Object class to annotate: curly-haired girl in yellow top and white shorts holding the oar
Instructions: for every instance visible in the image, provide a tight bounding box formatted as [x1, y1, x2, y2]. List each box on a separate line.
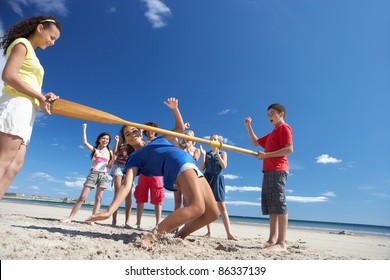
[0, 16, 61, 199]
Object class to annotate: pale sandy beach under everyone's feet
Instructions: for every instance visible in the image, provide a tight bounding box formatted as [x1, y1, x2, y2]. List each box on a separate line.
[0, 201, 390, 260]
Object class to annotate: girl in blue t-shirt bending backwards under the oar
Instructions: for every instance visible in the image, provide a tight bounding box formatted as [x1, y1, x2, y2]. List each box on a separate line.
[87, 98, 219, 249]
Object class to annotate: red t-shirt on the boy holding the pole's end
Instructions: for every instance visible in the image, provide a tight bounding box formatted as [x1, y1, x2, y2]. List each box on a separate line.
[257, 123, 292, 171]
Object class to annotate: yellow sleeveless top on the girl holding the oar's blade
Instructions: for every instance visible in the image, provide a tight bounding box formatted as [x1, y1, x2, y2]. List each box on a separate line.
[3, 38, 44, 111]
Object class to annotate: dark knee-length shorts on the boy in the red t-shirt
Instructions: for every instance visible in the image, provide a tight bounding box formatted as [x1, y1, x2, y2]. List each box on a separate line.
[261, 171, 288, 215]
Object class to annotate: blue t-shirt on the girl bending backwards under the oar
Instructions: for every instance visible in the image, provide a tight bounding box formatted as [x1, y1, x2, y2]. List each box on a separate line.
[126, 137, 195, 191]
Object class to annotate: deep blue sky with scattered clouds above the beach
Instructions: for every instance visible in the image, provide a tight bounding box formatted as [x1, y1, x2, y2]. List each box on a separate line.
[0, 0, 390, 226]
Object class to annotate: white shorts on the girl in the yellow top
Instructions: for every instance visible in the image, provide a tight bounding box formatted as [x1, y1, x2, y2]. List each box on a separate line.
[0, 94, 38, 145]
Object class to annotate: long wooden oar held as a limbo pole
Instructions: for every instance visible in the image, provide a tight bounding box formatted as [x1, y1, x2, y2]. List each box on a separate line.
[51, 98, 257, 156]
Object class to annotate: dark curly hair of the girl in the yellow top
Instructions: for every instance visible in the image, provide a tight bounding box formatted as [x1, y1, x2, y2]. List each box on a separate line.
[0, 16, 62, 55]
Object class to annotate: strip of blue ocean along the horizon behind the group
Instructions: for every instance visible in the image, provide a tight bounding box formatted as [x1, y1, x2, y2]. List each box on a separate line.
[2, 197, 390, 236]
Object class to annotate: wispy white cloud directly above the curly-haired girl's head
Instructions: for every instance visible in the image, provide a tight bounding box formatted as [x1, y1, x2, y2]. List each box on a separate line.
[7, 0, 69, 17]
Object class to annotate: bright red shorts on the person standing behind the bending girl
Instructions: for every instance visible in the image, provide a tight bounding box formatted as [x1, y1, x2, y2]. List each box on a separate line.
[134, 174, 165, 205]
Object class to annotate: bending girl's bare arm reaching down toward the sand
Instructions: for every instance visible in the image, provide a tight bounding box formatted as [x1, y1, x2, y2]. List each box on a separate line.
[85, 167, 138, 222]
